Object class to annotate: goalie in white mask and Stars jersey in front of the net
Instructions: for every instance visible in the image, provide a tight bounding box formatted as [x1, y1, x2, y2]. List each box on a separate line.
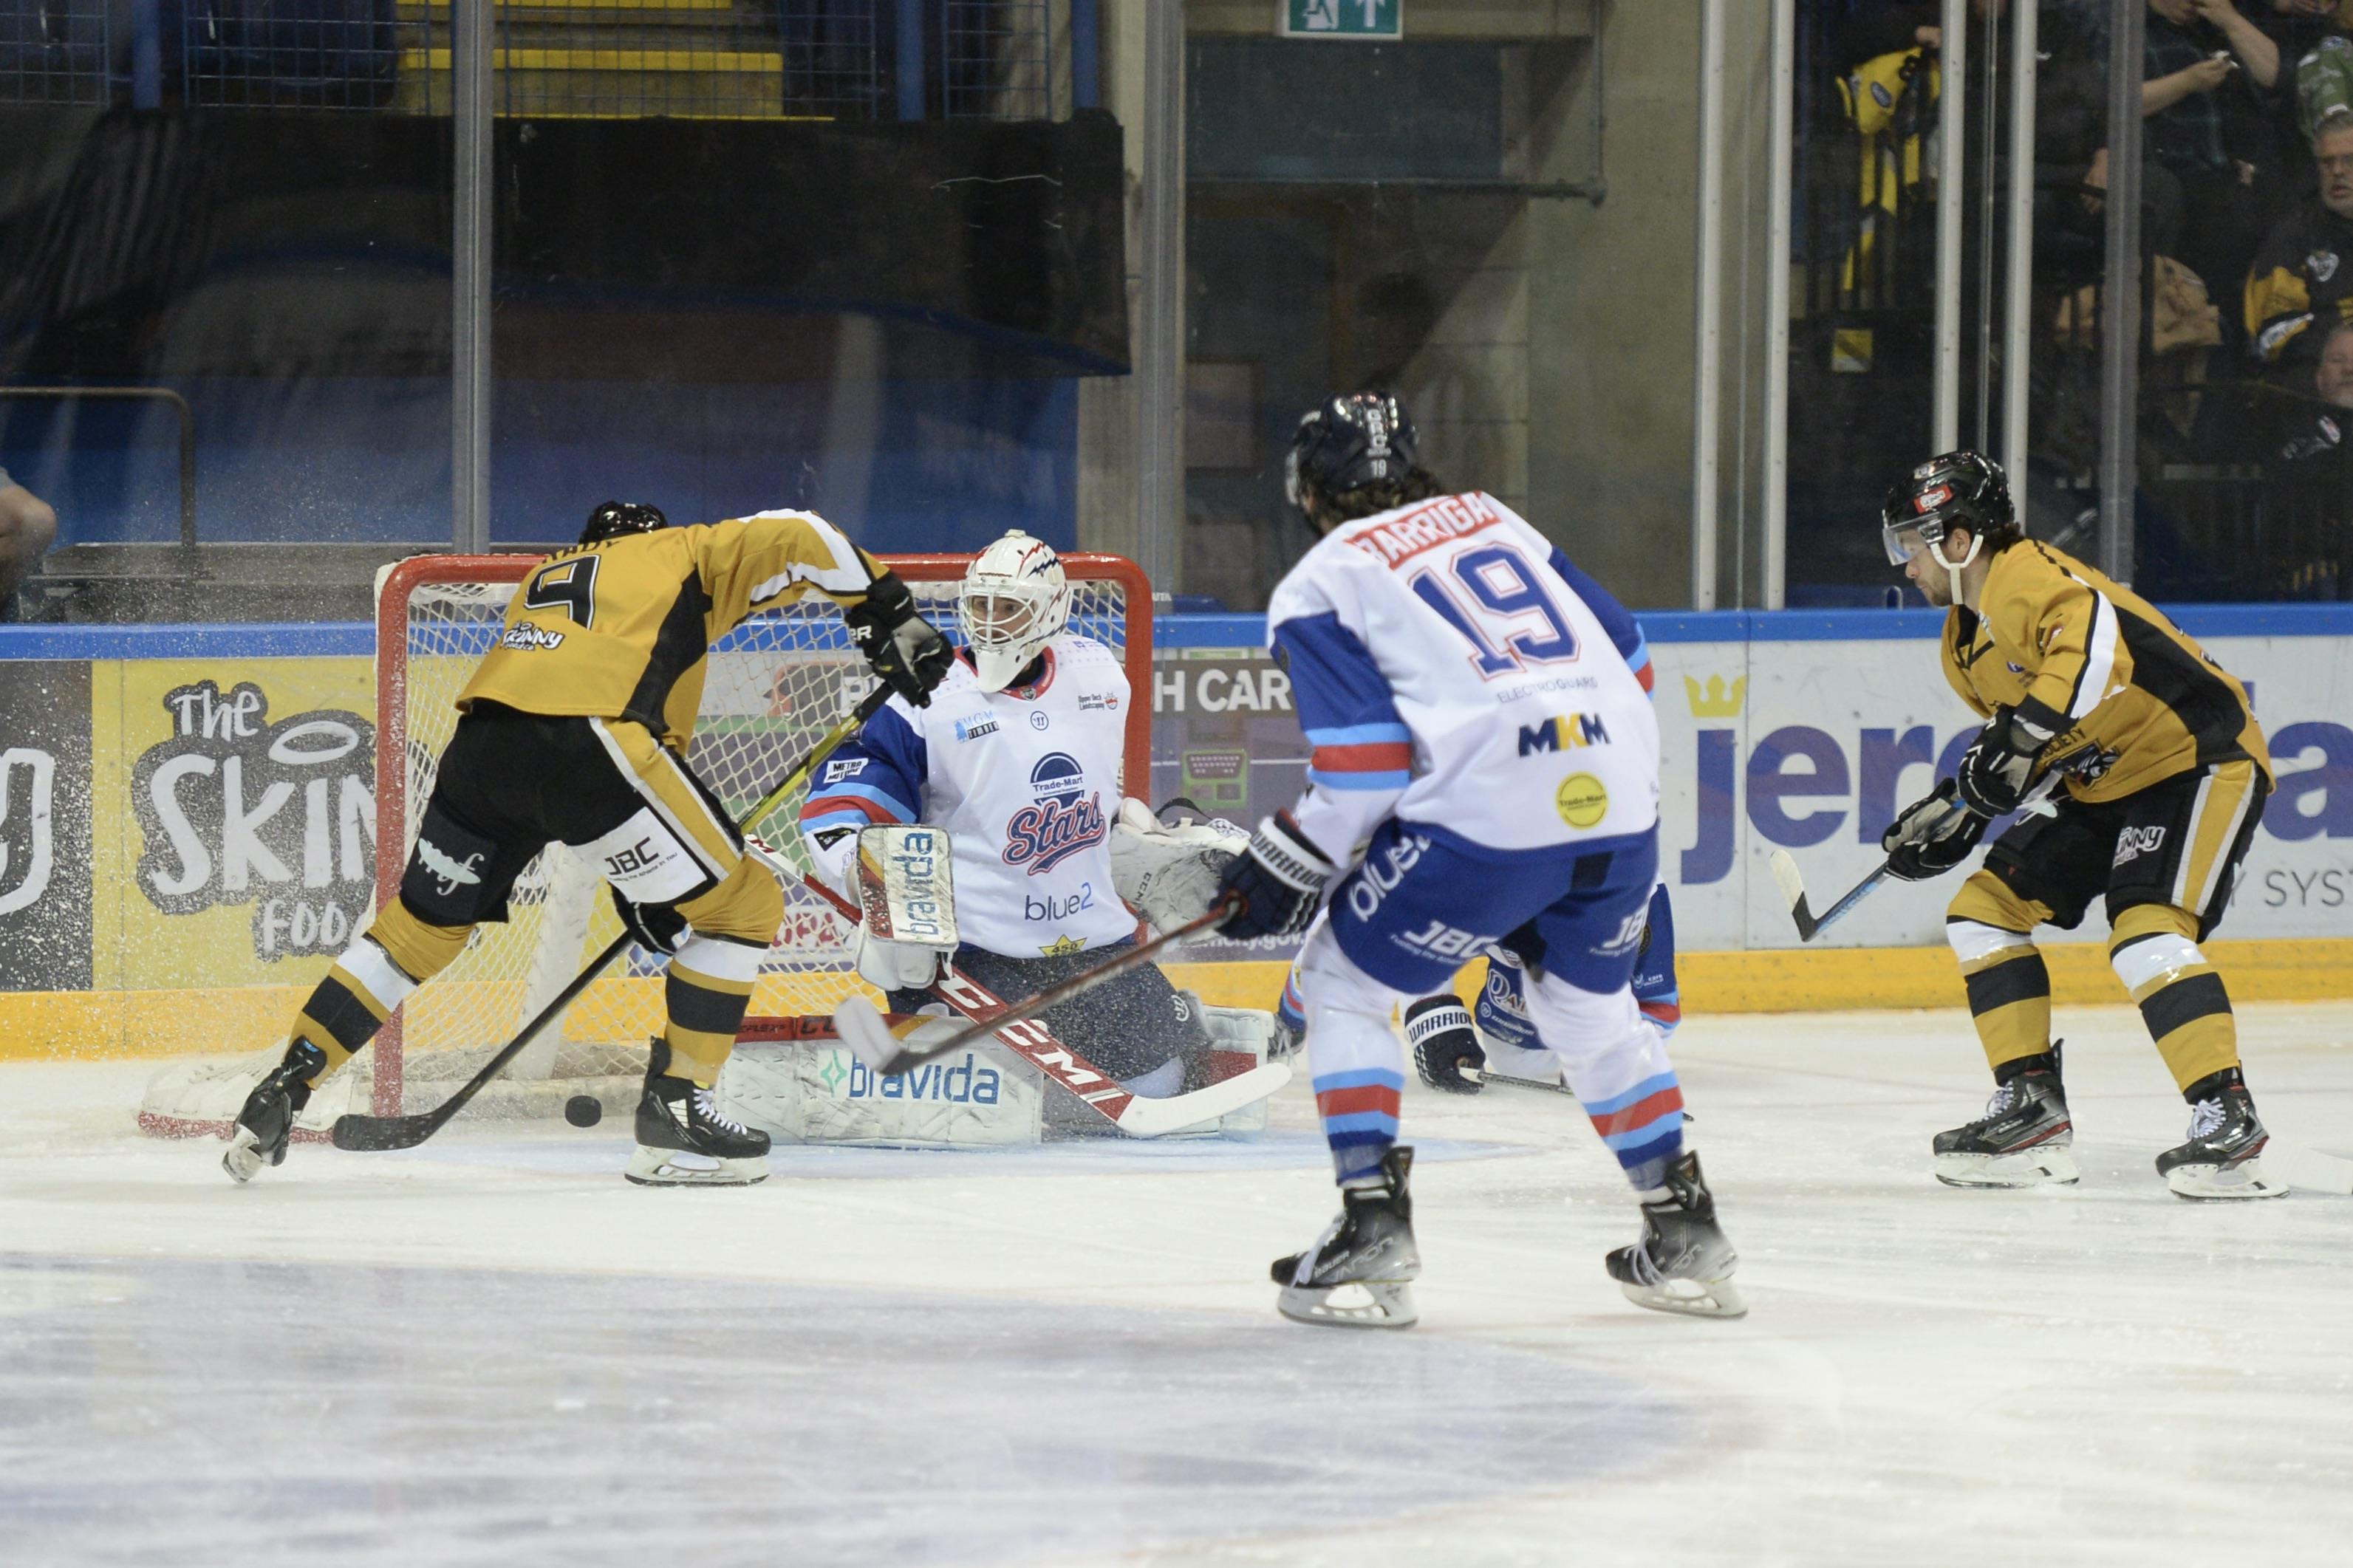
[800, 531, 1271, 1109]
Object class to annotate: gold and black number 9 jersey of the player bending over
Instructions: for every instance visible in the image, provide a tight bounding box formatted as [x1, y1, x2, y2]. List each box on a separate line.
[457, 513, 882, 750]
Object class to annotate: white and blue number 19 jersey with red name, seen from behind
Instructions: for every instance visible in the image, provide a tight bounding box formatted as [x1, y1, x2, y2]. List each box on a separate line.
[1266, 491, 1659, 865]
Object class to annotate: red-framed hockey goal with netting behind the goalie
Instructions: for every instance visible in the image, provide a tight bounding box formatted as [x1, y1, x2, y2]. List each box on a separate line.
[139, 555, 1150, 1135]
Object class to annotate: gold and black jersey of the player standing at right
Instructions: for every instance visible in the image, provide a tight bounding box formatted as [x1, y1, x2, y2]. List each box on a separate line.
[1944, 541, 2271, 801]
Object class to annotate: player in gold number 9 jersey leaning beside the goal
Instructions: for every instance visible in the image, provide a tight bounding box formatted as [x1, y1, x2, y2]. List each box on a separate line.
[221, 501, 953, 1185]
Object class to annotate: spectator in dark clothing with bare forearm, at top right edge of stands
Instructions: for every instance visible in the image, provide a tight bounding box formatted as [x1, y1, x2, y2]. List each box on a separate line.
[2141, 0, 2282, 322]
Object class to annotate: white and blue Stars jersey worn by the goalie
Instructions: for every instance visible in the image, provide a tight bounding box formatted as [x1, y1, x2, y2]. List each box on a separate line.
[800, 634, 1136, 956]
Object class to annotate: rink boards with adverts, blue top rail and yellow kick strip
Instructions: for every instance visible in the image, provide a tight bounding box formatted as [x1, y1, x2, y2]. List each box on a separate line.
[0, 604, 2353, 1055]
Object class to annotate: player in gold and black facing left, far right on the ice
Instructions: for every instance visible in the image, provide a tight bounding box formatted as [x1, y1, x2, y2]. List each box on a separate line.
[1880, 451, 2287, 1199]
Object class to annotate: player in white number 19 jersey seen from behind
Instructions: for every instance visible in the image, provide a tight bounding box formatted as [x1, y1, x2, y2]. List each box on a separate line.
[1223, 393, 1744, 1328]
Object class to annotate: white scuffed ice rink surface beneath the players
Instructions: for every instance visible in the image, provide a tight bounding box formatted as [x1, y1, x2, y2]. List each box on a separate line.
[0, 1004, 2353, 1568]
